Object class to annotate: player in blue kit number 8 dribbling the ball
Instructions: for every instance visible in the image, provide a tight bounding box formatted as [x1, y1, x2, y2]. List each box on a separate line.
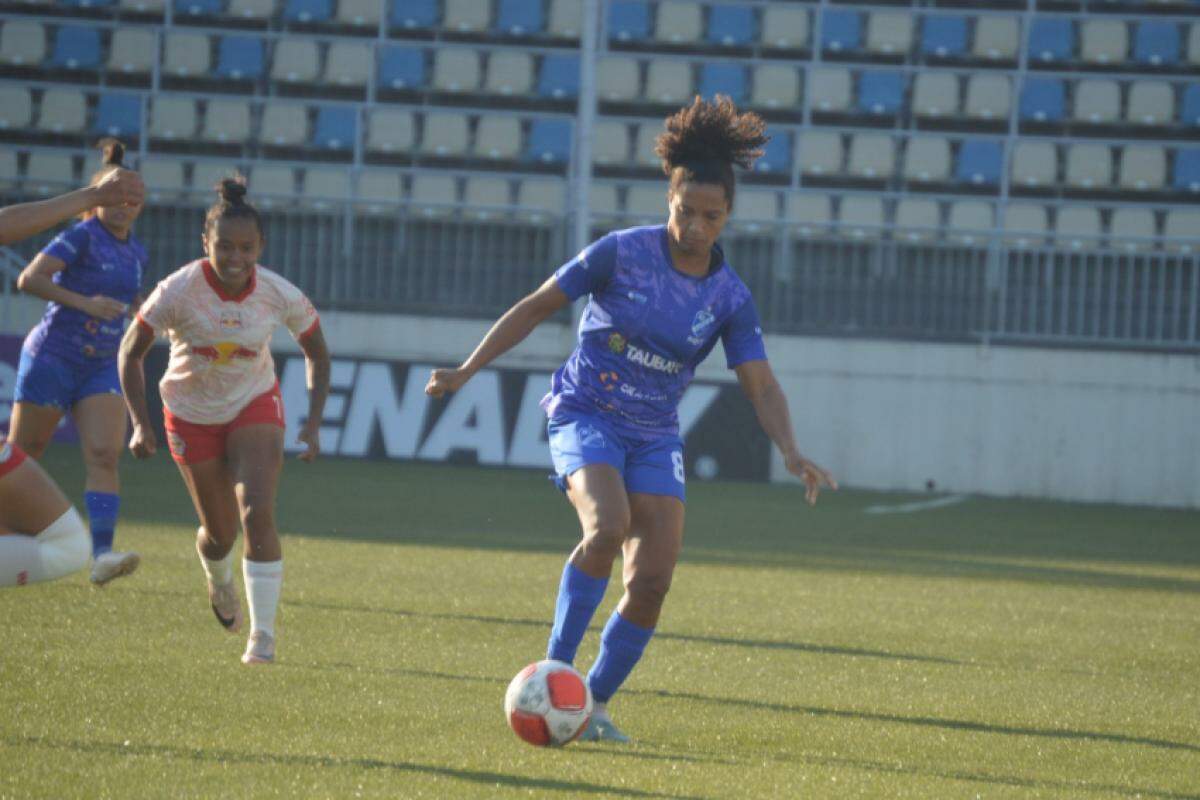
[425, 96, 836, 741]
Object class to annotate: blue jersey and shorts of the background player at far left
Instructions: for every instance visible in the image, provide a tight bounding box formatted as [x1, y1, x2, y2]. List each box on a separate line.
[25, 217, 146, 363]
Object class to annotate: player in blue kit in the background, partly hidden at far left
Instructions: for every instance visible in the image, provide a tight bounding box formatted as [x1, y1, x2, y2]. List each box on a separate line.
[8, 139, 146, 585]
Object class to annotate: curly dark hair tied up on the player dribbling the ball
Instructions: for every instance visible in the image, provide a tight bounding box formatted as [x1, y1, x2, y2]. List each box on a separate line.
[654, 95, 770, 207]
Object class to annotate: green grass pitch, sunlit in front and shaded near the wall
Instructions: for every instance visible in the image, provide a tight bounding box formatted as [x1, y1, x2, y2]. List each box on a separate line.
[0, 447, 1200, 798]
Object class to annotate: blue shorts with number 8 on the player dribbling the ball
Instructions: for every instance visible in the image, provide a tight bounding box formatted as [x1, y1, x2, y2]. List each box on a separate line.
[547, 411, 685, 500]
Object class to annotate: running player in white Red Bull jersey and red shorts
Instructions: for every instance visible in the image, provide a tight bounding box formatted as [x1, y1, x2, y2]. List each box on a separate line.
[120, 179, 330, 663]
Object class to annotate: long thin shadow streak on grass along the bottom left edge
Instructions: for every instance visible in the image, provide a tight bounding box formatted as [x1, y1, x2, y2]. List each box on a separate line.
[0, 736, 702, 800]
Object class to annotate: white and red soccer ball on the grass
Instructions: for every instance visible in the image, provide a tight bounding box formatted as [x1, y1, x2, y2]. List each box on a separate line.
[504, 658, 592, 747]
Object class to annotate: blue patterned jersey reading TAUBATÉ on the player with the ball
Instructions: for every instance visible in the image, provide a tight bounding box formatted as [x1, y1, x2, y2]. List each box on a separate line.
[542, 225, 767, 434]
